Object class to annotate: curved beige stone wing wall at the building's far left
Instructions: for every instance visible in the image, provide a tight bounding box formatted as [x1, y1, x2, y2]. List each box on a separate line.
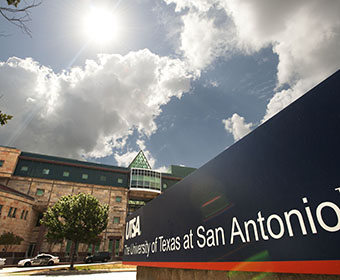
[0, 190, 37, 252]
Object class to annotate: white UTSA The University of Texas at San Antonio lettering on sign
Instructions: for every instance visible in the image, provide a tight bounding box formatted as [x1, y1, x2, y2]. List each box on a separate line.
[124, 197, 340, 258]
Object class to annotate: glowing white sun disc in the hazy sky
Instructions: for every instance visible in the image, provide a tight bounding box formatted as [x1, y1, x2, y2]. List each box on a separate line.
[83, 7, 118, 44]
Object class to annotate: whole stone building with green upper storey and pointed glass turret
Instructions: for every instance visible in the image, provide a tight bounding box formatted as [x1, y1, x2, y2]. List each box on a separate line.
[0, 147, 195, 262]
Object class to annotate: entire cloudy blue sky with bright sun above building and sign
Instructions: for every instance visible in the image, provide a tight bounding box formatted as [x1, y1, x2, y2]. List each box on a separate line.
[0, 0, 340, 171]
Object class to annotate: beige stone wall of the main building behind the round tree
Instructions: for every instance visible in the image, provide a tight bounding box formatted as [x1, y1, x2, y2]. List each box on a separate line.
[8, 176, 128, 252]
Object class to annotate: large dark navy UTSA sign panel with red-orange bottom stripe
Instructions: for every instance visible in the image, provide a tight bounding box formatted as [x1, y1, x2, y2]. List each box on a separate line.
[123, 71, 340, 275]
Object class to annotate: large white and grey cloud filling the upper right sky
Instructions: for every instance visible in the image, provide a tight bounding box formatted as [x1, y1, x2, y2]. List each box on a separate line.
[165, 0, 340, 120]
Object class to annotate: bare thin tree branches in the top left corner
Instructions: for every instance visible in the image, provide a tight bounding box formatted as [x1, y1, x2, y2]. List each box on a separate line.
[0, 0, 41, 37]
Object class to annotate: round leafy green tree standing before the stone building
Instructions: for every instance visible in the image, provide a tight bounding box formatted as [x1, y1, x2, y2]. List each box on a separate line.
[41, 193, 109, 269]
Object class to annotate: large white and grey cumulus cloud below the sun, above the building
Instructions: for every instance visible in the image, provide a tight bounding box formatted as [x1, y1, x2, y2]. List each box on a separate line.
[0, 50, 194, 158]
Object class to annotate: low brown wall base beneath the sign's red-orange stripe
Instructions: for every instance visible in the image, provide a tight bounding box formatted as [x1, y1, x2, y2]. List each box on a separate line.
[137, 266, 340, 280]
